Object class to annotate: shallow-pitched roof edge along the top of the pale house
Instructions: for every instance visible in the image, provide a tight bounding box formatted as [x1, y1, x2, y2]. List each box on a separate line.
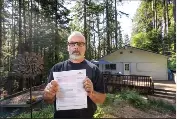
[100, 45, 168, 59]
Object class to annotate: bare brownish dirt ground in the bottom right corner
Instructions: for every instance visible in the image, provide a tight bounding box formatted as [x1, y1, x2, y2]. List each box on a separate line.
[103, 99, 176, 118]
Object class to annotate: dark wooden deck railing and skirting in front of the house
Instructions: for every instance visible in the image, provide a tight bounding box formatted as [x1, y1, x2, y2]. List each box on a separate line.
[103, 74, 154, 94]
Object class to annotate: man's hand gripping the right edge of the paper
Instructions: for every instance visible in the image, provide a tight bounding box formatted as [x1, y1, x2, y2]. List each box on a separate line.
[84, 77, 94, 96]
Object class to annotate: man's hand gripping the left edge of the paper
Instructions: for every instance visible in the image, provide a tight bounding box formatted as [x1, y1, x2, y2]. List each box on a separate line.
[44, 80, 59, 103]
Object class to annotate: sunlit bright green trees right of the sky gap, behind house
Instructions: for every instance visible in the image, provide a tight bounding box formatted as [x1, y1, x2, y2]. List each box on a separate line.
[131, 0, 176, 55]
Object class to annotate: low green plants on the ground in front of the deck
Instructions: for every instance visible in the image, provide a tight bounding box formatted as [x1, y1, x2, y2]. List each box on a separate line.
[103, 89, 176, 113]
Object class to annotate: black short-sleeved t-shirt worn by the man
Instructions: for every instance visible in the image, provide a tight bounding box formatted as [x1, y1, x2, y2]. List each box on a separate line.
[48, 60, 105, 118]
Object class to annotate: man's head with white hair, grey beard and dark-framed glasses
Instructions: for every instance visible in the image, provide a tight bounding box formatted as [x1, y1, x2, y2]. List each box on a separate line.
[68, 31, 86, 60]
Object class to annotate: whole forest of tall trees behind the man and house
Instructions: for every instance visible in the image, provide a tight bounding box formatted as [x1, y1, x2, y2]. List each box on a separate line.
[0, 0, 176, 79]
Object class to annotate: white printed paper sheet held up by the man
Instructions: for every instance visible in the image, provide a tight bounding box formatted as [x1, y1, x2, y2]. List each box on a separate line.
[53, 69, 87, 110]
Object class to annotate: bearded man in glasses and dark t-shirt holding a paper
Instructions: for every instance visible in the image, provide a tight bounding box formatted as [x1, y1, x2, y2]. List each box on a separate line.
[44, 31, 106, 118]
